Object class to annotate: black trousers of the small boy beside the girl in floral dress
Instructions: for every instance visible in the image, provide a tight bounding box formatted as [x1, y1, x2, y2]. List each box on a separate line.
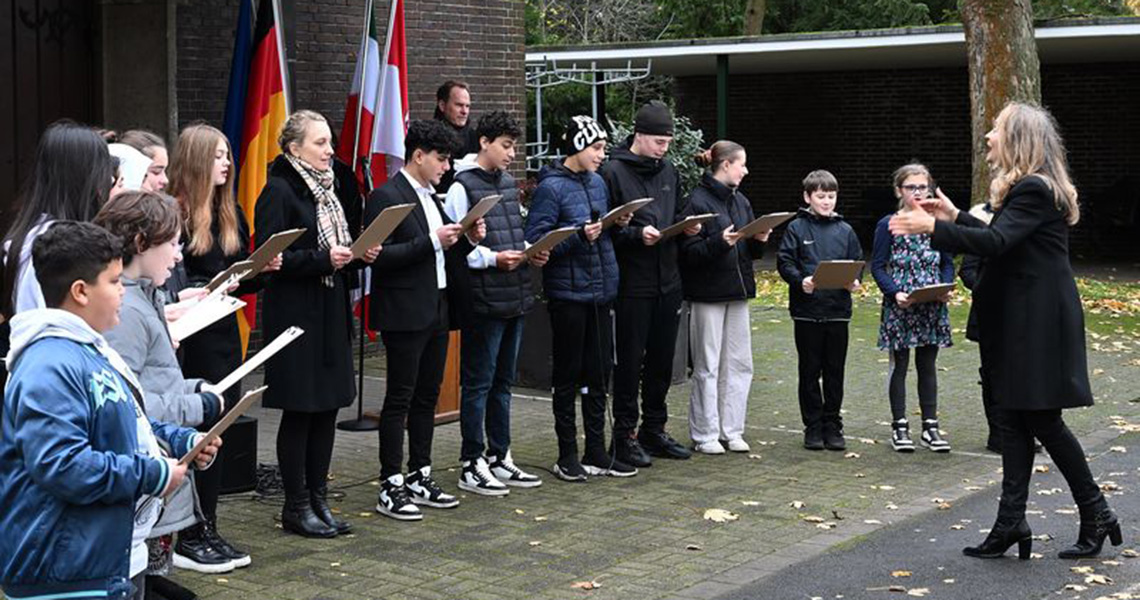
[795, 319, 847, 427]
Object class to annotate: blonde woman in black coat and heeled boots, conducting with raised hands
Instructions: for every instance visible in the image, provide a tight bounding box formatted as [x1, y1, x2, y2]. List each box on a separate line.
[890, 103, 1122, 559]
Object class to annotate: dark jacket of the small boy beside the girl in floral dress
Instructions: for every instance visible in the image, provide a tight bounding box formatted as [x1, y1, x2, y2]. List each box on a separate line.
[776, 209, 863, 321]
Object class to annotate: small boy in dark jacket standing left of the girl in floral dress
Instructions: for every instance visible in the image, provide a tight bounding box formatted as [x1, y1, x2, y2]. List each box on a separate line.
[776, 170, 863, 451]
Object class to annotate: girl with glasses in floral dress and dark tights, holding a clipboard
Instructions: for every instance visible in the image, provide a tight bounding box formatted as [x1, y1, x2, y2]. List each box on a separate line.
[871, 164, 954, 452]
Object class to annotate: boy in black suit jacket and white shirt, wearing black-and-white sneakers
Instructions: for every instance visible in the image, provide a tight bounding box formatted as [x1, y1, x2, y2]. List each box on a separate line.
[365, 121, 487, 520]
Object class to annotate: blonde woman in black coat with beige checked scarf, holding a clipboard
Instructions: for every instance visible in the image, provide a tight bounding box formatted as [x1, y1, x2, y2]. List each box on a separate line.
[254, 111, 381, 537]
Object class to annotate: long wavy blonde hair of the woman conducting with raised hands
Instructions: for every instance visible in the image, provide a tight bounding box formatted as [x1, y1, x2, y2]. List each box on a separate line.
[990, 103, 1081, 225]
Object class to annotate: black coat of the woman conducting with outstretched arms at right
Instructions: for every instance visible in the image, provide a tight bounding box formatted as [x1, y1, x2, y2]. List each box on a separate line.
[930, 177, 1092, 411]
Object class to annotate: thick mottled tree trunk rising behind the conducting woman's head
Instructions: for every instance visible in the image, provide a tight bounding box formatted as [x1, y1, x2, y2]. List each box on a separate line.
[960, 0, 1041, 204]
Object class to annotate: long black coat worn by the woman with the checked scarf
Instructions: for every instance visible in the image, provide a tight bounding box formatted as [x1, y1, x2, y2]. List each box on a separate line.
[254, 156, 360, 413]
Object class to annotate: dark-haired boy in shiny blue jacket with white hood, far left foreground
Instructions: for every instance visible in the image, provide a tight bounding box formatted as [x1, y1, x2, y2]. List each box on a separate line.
[0, 221, 220, 600]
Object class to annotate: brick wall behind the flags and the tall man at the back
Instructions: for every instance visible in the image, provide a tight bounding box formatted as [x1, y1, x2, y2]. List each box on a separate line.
[177, 0, 526, 149]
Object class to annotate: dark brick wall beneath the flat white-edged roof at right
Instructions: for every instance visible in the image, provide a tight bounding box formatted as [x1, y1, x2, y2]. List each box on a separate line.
[674, 63, 1140, 254]
